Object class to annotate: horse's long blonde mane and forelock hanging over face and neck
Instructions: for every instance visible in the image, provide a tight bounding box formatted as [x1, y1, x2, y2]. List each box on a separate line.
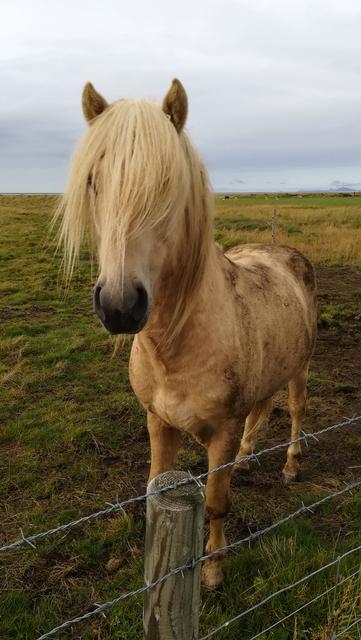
[55, 100, 212, 339]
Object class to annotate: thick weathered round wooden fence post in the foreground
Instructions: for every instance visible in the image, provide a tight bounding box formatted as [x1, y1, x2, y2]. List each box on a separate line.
[143, 471, 204, 640]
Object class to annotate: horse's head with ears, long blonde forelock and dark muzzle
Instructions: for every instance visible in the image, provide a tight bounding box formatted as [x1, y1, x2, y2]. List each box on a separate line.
[56, 80, 211, 334]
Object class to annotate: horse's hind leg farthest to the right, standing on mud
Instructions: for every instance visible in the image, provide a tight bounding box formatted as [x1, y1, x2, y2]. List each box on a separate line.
[282, 363, 309, 484]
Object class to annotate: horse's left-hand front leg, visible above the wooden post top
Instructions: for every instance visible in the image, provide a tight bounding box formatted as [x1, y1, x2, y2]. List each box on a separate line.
[147, 411, 181, 482]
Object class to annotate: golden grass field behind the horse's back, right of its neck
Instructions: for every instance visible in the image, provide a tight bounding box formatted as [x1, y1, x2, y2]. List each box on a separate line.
[216, 195, 361, 266]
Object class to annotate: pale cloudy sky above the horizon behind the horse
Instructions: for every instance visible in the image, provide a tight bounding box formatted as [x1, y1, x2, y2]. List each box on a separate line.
[0, 0, 361, 192]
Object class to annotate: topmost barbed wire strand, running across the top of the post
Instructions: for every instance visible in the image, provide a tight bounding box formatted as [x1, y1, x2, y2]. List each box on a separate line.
[0, 416, 361, 552]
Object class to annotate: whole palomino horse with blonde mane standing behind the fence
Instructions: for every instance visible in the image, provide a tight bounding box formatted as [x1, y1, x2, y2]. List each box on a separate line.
[58, 80, 316, 587]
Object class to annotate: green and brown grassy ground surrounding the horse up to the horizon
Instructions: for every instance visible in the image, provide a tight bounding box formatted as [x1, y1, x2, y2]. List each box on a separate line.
[0, 195, 361, 640]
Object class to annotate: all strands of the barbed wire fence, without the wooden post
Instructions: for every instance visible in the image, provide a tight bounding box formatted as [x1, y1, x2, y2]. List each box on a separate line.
[0, 416, 361, 640]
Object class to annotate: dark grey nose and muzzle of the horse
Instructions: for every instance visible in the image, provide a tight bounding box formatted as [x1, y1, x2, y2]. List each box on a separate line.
[94, 285, 148, 334]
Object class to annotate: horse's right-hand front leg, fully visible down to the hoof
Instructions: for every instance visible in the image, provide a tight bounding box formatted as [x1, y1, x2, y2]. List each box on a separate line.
[202, 424, 239, 588]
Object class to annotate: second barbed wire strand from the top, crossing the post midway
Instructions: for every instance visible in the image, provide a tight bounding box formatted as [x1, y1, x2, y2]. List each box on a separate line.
[37, 480, 361, 640]
